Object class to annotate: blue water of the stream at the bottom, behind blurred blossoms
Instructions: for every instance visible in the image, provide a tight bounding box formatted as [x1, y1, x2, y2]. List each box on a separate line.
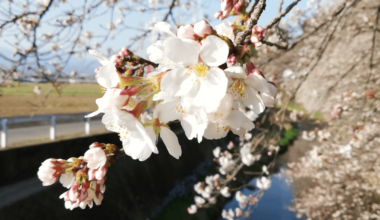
[218, 173, 298, 220]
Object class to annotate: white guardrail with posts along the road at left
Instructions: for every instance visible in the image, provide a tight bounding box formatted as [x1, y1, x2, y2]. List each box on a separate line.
[0, 113, 99, 148]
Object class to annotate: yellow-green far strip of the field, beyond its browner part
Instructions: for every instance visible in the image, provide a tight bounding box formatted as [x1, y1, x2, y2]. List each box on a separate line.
[0, 82, 102, 96]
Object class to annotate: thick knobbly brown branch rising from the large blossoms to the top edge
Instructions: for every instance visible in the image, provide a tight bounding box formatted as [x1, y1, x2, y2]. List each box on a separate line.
[234, 0, 266, 46]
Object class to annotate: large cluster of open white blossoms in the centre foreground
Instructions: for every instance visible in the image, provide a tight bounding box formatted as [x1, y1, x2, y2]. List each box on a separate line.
[87, 21, 277, 163]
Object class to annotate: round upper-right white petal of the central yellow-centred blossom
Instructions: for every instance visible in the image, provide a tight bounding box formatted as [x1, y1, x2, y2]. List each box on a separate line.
[200, 36, 229, 67]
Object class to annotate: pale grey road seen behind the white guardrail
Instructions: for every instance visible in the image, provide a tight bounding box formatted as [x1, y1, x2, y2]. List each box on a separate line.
[4, 120, 106, 144]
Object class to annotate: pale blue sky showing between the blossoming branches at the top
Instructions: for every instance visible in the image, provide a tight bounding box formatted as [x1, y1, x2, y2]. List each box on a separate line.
[0, 0, 307, 74]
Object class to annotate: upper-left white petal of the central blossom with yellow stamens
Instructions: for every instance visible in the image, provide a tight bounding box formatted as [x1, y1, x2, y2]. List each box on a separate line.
[164, 37, 200, 66]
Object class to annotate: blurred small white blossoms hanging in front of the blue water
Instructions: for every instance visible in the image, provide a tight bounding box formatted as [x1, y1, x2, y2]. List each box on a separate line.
[187, 124, 279, 219]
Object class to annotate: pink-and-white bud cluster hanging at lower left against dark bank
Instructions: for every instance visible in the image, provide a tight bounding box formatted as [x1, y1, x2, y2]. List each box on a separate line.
[37, 143, 120, 210]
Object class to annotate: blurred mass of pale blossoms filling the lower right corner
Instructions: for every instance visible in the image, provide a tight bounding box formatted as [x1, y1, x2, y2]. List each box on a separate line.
[287, 89, 380, 219]
